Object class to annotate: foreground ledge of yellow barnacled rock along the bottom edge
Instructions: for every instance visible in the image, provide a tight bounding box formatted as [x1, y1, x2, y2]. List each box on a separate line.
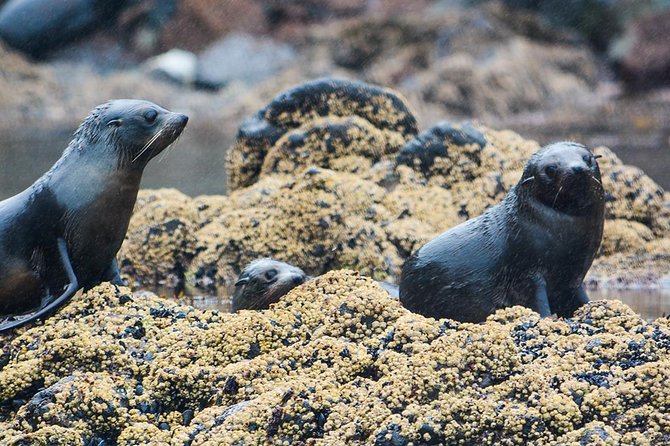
[0, 270, 670, 445]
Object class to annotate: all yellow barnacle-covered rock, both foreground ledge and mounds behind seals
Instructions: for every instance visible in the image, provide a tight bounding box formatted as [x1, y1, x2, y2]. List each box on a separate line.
[0, 79, 670, 445]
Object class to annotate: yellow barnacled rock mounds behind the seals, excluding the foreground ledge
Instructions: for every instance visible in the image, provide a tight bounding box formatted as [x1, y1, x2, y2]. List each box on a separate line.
[120, 79, 670, 291]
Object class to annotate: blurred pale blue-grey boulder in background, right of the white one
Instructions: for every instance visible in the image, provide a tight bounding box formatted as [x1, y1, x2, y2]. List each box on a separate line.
[197, 33, 297, 88]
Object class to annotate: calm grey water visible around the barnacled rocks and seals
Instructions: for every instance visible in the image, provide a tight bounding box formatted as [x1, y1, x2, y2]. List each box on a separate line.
[0, 129, 670, 318]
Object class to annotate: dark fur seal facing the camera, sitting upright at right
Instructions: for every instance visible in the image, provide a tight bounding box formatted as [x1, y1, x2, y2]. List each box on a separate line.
[400, 142, 605, 322]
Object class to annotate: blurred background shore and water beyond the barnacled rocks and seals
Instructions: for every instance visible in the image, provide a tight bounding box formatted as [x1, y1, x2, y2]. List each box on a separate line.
[0, 0, 670, 197]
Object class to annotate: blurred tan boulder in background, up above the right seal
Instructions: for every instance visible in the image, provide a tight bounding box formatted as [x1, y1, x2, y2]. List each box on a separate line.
[418, 37, 597, 116]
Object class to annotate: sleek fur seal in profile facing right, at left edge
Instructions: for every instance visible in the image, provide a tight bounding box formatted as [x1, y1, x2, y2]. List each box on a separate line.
[0, 99, 188, 332]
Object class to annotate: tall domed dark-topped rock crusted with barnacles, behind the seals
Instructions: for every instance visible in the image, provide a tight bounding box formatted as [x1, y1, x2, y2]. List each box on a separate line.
[227, 79, 417, 191]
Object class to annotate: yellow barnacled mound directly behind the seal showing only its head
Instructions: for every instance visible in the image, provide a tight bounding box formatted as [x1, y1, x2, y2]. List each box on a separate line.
[189, 168, 402, 285]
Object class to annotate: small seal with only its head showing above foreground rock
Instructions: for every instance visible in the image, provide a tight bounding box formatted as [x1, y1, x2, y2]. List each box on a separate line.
[232, 258, 309, 313]
